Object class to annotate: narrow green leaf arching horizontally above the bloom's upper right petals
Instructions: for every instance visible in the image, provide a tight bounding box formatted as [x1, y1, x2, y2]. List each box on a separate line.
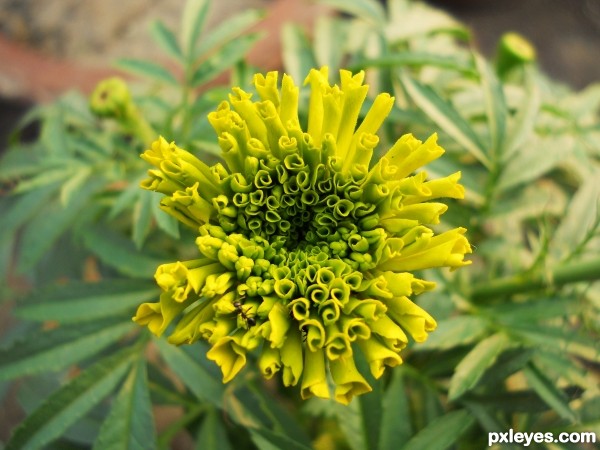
[351, 51, 475, 76]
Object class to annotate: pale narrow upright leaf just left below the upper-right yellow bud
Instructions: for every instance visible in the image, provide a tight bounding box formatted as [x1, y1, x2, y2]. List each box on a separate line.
[473, 53, 508, 161]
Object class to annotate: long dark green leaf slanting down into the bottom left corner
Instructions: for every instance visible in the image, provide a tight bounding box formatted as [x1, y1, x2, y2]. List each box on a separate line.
[5, 349, 132, 450]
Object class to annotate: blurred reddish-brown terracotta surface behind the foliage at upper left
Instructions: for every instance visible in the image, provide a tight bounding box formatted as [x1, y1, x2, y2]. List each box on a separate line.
[0, 0, 328, 102]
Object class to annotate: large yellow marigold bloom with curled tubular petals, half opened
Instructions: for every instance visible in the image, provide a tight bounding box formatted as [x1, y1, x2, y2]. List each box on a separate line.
[134, 68, 471, 404]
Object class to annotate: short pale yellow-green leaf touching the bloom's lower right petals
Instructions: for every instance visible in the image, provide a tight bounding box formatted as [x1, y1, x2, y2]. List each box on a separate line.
[414, 316, 489, 352]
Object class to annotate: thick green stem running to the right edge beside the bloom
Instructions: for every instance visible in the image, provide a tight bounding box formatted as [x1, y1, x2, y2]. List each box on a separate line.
[471, 258, 600, 300]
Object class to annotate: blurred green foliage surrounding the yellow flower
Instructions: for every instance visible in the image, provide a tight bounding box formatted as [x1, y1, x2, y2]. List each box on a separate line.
[0, 0, 600, 450]
